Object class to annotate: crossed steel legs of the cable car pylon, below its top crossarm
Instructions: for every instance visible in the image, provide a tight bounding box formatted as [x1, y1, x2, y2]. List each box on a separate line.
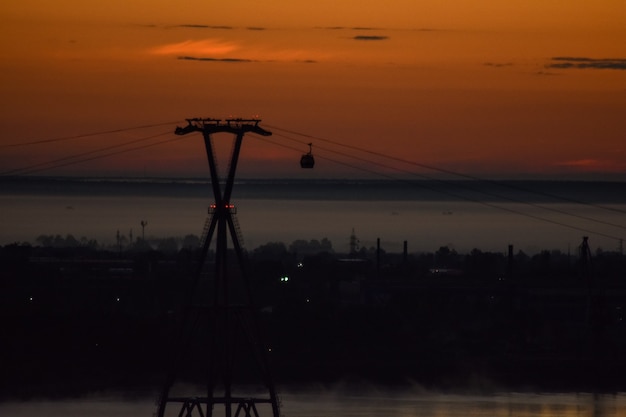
[157, 127, 280, 417]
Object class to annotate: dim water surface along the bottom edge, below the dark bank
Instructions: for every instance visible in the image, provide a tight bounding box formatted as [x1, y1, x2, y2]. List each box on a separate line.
[0, 390, 626, 417]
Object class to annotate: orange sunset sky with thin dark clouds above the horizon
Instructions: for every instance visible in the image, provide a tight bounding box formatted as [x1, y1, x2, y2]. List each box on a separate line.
[0, 0, 626, 180]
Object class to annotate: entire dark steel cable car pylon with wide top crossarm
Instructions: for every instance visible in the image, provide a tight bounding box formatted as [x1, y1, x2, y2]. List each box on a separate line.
[157, 118, 280, 417]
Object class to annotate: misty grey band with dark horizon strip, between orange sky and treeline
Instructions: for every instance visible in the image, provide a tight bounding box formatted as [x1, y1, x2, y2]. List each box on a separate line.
[0, 176, 626, 254]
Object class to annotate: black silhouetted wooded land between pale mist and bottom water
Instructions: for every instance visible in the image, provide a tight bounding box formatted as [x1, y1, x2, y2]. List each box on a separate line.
[0, 236, 626, 396]
